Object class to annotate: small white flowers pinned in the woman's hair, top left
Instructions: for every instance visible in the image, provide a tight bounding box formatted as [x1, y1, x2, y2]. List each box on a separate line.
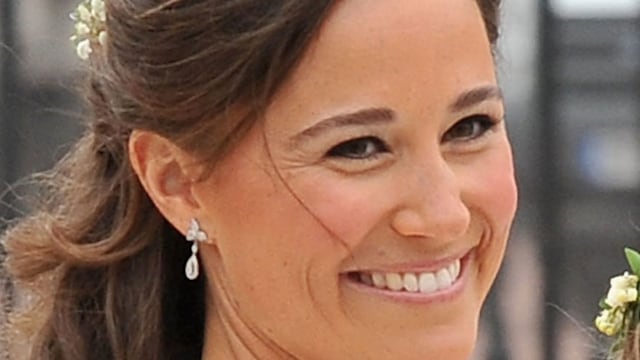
[69, 0, 107, 60]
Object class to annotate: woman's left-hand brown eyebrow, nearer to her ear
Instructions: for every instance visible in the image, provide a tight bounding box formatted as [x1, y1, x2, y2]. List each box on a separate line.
[290, 107, 396, 146]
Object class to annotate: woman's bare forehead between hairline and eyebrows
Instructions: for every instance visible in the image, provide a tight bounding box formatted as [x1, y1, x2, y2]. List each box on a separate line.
[266, 0, 495, 119]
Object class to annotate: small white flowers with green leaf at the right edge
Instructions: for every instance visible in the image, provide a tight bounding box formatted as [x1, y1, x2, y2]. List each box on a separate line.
[595, 248, 640, 355]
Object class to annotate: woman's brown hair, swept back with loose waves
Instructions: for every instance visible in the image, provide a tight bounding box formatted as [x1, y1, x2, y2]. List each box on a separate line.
[3, 0, 499, 360]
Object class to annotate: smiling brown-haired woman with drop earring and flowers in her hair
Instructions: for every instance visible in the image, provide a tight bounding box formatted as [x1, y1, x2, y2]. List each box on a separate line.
[5, 0, 516, 360]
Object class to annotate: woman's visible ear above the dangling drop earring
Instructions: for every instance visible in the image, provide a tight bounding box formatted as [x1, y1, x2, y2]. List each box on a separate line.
[129, 130, 200, 234]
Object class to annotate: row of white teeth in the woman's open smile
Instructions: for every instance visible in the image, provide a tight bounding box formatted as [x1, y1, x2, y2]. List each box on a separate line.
[359, 260, 461, 294]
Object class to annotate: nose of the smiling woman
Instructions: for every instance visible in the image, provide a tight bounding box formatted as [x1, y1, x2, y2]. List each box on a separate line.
[392, 158, 471, 240]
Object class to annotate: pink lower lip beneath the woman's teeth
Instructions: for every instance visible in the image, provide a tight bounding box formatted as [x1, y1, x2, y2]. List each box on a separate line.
[341, 253, 473, 305]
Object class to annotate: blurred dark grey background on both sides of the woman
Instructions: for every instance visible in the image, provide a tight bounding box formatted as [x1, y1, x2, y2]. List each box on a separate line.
[0, 0, 640, 360]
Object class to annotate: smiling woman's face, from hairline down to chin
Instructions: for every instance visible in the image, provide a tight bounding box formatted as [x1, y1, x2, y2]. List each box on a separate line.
[194, 0, 516, 359]
